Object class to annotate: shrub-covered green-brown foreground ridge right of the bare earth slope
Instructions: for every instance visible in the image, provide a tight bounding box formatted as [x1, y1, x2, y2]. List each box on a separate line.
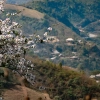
[26, 56, 100, 100]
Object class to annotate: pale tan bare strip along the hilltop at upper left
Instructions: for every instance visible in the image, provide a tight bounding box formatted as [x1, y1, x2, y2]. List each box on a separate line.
[5, 4, 44, 19]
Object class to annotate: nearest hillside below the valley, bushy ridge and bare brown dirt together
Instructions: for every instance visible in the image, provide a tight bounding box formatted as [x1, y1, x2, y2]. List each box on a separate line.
[0, 56, 100, 100]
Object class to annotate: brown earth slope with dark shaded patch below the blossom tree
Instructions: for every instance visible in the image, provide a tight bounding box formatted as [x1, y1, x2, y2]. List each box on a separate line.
[0, 67, 51, 100]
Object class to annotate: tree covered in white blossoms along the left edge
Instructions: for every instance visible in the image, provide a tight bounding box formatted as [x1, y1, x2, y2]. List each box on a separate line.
[0, 0, 52, 76]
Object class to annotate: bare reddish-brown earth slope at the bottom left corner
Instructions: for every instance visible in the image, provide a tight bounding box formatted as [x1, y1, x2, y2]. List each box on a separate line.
[3, 85, 51, 100]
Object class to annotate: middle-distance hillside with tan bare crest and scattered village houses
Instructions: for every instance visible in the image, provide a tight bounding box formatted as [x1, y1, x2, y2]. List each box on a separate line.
[0, 4, 100, 70]
